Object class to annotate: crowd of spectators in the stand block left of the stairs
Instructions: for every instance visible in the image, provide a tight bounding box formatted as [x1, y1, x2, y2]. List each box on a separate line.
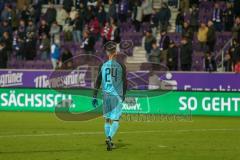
[0, 0, 129, 69]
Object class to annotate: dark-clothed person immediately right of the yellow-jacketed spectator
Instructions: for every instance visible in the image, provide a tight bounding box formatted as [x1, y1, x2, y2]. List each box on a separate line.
[207, 21, 216, 53]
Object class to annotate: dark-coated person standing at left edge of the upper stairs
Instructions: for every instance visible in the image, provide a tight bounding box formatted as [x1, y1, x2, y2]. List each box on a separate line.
[159, 3, 171, 30]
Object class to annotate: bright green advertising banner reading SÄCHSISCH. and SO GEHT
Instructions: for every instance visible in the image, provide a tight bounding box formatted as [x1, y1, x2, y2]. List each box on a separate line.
[0, 88, 240, 116]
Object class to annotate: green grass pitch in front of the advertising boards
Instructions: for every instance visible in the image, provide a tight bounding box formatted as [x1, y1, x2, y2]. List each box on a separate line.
[0, 112, 240, 160]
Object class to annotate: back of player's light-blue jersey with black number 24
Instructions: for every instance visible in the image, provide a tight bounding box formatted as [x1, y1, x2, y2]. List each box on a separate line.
[101, 60, 124, 96]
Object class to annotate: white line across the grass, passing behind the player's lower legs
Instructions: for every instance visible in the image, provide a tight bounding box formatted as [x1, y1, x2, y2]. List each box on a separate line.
[0, 128, 240, 138]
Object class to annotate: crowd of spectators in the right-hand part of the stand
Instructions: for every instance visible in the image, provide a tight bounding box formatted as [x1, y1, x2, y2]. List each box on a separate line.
[143, 0, 240, 72]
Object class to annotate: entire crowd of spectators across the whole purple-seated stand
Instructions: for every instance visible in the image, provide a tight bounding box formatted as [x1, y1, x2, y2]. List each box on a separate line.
[0, 0, 240, 71]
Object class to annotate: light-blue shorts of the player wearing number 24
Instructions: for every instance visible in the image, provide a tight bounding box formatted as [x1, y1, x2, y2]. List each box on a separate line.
[103, 93, 123, 120]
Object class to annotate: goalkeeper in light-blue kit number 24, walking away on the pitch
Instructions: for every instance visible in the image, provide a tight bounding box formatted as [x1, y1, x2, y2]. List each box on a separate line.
[92, 42, 127, 151]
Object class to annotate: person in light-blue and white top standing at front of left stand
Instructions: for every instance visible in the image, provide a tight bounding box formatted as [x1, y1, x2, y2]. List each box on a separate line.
[51, 38, 60, 69]
